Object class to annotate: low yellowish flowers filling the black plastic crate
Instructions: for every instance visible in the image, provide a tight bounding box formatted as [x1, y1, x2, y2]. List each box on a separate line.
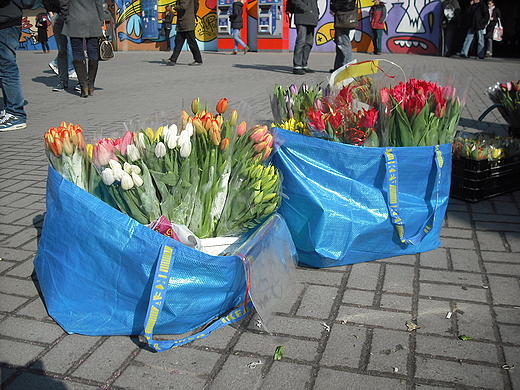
[452, 133, 520, 161]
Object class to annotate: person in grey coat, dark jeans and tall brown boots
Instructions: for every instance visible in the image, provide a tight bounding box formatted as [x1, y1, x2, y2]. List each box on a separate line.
[60, 0, 105, 98]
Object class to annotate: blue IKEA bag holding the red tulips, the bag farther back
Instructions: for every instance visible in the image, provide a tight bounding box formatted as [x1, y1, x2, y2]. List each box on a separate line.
[273, 128, 451, 268]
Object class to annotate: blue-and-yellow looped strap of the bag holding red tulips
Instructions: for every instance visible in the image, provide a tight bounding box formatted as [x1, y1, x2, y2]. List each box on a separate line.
[384, 145, 444, 245]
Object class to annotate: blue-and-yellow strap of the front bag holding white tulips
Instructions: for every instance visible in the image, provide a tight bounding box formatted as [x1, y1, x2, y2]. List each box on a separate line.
[144, 245, 253, 352]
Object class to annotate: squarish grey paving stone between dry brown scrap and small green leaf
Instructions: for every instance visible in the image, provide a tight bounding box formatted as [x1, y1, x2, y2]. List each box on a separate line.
[417, 299, 454, 336]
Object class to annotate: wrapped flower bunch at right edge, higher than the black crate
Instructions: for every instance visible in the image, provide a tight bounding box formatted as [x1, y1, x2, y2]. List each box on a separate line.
[488, 80, 520, 131]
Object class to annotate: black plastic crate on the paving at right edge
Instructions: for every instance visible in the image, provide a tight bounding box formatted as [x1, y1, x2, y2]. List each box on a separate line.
[450, 156, 520, 202]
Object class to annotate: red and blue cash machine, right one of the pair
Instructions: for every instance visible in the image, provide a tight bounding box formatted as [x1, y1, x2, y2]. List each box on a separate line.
[257, 0, 289, 51]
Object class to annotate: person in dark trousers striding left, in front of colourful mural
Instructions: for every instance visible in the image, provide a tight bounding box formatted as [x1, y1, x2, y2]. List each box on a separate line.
[163, 0, 202, 65]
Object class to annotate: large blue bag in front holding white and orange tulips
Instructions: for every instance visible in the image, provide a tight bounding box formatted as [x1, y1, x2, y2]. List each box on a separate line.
[34, 167, 295, 351]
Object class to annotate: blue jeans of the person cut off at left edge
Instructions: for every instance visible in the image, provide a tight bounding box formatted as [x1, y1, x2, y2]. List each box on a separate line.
[0, 26, 27, 121]
